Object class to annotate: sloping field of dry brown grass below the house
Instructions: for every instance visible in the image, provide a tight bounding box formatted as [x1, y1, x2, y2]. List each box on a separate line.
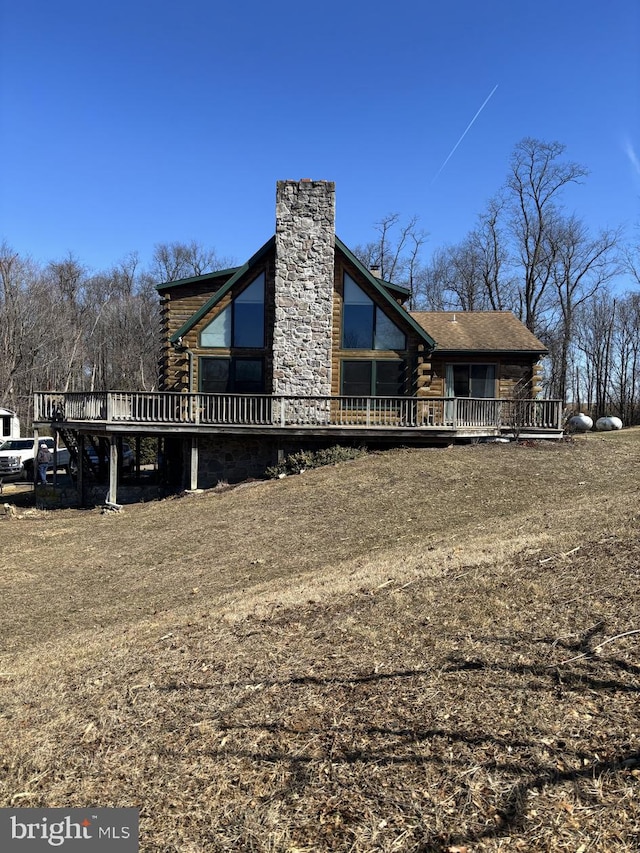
[0, 429, 640, 853]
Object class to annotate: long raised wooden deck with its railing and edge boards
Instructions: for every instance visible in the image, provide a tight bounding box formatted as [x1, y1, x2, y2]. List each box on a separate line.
[34, 391, 562, 442]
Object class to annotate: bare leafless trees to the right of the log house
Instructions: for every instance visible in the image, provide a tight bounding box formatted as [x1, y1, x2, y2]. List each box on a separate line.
[355, 138, 640, 424]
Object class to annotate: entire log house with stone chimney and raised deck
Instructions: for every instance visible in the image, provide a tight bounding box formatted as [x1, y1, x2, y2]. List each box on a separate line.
[35, 180, 562, 502]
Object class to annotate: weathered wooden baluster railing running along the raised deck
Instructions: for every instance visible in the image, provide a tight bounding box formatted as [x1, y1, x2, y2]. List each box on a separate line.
[34, 391, 562, 431]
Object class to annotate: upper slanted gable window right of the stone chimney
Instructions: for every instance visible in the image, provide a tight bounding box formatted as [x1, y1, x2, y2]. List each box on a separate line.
[342, 273, 407, 350]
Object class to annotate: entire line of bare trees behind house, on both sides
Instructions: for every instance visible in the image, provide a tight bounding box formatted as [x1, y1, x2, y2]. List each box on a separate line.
[0, 138, 640, 432]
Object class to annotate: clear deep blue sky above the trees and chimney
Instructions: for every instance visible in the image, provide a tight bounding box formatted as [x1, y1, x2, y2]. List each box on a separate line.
[0, 0, 640, 270]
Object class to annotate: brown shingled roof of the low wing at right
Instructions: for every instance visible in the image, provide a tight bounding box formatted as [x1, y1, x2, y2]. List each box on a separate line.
[411, 311, 547, 355]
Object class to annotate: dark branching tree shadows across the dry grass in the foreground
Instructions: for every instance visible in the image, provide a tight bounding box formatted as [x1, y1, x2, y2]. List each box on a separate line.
[156, 644, 640, 853]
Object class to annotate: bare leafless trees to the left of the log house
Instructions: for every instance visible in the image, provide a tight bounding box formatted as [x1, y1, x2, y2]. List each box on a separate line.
[0, 242, 229, 429]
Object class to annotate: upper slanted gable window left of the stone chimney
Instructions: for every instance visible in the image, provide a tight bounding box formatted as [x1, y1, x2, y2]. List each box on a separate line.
[200, 273, 265, 349]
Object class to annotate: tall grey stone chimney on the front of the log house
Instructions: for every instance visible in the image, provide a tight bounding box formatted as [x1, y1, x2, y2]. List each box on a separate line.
[273, 179, 335, 396]
